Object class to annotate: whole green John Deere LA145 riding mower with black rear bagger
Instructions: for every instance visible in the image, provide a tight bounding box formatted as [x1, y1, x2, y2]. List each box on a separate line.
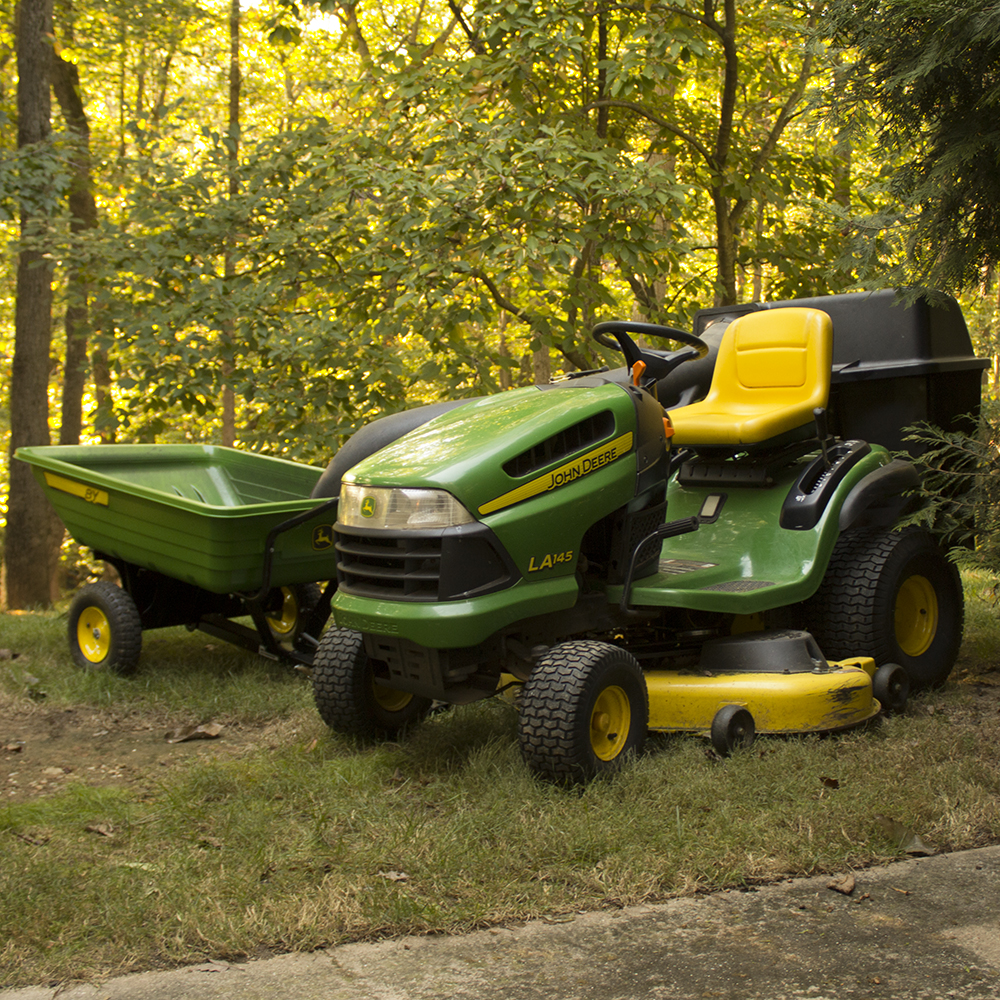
[313, 292, 982, 782]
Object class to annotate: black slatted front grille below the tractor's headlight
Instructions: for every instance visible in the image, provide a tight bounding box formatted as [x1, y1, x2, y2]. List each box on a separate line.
[336, 523, 520, 601]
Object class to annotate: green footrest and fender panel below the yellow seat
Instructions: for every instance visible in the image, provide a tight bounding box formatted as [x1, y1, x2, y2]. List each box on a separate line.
[608, 445, 891, 614]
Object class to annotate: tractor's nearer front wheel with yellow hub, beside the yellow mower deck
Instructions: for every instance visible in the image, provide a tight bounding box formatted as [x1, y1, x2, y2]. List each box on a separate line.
[518, 640, 649, 785]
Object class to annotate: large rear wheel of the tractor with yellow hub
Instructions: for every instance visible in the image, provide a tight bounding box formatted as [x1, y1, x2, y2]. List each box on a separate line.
[806, 528, 965, 691]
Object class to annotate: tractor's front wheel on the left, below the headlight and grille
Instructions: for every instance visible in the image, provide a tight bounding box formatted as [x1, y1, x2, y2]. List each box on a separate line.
[312, 628, 431, 739]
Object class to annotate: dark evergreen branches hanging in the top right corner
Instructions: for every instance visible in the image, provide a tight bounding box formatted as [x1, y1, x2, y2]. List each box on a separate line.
[828, 0, 1000, 290]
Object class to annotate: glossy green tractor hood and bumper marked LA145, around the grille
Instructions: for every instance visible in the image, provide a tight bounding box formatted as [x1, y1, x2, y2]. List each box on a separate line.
[333, 385, 636, 649]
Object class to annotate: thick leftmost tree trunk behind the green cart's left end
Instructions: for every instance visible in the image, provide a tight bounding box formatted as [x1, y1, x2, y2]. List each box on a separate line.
[4, 0, 55, 608]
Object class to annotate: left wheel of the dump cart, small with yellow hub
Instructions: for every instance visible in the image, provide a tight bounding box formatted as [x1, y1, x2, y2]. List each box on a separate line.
[68, 582, 142, 674]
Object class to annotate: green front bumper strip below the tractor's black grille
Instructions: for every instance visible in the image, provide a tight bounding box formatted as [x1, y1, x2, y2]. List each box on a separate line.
[334, 576, 577, 649]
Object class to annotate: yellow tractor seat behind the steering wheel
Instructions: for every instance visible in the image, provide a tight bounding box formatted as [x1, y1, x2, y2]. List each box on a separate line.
[668, 308, 833, 450]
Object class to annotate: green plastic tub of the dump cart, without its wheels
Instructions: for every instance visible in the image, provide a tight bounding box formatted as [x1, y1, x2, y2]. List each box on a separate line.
[17, 445, 336, 594]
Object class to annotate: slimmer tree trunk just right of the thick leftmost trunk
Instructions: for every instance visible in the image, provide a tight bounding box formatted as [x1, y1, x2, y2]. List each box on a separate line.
[52, 41, 97, 444]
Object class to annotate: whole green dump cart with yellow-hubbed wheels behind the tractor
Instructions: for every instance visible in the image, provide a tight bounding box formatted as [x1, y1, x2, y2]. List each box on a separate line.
[17, 444, 337, 672]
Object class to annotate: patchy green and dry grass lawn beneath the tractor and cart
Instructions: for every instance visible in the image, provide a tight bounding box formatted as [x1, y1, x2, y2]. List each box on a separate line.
[0, 578, 1000, 986]
